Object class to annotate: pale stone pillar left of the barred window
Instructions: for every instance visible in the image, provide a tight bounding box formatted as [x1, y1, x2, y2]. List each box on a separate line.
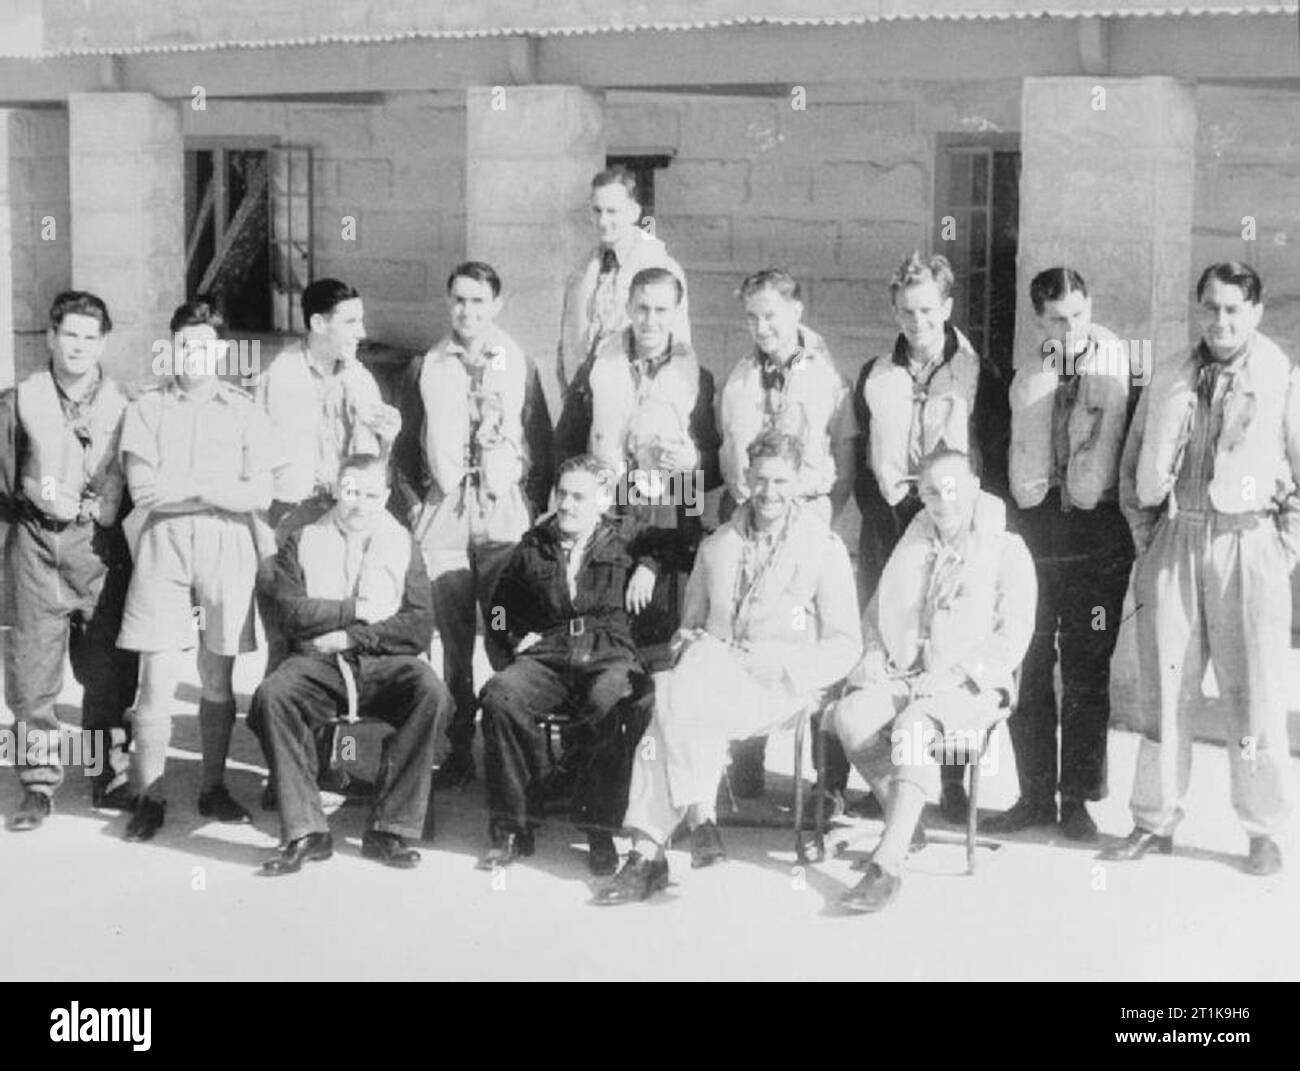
[69, 94, 185, 383]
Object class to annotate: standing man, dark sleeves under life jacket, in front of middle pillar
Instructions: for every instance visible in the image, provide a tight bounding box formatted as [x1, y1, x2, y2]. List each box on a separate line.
[389, 261, 554, 789]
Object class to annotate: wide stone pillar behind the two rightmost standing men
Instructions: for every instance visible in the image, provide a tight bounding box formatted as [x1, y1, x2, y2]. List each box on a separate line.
[1015, 78, 1196, 738]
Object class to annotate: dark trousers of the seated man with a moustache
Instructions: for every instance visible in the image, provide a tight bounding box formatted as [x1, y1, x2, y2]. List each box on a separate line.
[481, 636, 653, 833]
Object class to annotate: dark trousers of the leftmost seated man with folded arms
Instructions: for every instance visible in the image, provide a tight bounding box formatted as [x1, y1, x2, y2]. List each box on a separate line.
[248, 654, 451, 844]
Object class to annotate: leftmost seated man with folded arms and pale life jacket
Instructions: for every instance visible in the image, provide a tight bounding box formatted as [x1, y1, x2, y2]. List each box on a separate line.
[248, 456, 451, 876]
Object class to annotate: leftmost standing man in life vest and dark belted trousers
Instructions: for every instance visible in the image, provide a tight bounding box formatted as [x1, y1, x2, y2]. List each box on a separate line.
[0, 290, 138, 831]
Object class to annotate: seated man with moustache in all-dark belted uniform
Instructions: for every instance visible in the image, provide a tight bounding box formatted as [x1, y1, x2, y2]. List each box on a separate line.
[480, 454, 675, 875]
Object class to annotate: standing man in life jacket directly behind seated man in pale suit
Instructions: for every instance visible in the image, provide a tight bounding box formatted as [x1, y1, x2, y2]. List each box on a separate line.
[719, 268, 857, 798]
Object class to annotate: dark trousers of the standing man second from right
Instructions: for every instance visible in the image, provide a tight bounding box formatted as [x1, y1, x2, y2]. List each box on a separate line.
[1009, 489, 1134, 803]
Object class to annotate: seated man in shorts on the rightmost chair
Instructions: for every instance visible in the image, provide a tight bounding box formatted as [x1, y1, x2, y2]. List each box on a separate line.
[828, 447, 1037, 911]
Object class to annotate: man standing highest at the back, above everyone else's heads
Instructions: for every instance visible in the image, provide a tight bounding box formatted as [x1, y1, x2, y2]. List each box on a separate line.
[556, 166, 690, 393]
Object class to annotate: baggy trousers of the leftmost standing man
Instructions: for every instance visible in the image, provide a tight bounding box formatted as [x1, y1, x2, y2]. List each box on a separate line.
[5, 516, 139, 794]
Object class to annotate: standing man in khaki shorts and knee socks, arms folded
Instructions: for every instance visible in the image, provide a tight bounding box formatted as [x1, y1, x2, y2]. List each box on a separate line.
[117, 302, 274, 841]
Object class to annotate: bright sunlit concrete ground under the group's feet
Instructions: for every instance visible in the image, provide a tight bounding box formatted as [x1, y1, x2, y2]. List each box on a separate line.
[0, 639, 1300, 980]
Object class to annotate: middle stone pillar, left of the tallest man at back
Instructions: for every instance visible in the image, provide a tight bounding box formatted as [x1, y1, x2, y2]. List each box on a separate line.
[465, 86, 605, 420]
